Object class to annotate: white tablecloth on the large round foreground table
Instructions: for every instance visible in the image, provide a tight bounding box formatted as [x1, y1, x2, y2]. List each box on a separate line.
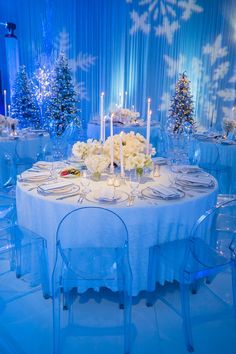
[16, 166, 217, 295]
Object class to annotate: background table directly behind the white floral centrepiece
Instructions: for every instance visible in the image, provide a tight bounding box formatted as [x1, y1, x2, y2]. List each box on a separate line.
[87, 122, 160, 147]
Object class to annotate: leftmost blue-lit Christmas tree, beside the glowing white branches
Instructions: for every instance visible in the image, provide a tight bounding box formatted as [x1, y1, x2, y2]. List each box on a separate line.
[11, 65, 40, 128]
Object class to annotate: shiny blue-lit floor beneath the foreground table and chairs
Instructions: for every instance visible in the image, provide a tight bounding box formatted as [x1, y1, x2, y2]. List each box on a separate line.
[0, 264, 236, 354]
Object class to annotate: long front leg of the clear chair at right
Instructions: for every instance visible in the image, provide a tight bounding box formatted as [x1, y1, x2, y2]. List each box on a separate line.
[180, 284, 194, 353]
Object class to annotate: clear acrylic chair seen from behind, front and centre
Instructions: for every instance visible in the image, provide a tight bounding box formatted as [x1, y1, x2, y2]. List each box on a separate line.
[52, 207, 132, 354]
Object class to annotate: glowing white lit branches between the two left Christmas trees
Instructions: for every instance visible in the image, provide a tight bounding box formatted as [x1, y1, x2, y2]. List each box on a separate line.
[32, 65, 51, 125]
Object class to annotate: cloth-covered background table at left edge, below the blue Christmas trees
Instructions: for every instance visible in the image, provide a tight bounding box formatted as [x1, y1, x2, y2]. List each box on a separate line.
[0, 131, 50, 186]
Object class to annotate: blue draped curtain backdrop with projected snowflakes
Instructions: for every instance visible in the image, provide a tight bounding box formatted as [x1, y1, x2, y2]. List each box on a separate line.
[0, 0, 236, 129]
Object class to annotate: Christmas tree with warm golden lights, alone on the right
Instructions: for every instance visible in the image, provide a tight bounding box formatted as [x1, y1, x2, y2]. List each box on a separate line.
[168, 73, 195, 133]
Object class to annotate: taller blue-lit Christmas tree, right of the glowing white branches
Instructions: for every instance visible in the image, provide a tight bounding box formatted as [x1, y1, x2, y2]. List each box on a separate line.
[45, 54, 80, 136]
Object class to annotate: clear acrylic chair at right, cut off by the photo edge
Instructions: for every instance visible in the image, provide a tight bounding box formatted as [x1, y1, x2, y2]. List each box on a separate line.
[147, 199, 236, 352]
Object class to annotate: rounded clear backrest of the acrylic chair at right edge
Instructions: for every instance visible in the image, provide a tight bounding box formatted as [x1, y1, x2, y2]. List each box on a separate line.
[183, 199, 236, 268]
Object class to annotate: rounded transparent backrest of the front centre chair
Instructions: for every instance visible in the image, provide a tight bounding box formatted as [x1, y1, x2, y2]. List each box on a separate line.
[54, 207, 128, 278]
